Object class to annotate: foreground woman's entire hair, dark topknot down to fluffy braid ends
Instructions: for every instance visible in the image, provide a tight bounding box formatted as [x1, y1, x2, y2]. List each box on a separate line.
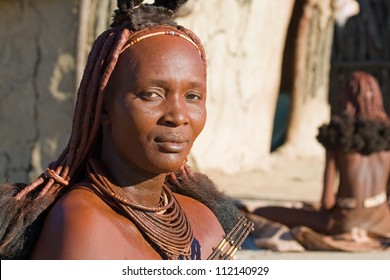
[0, 0, 233, 259]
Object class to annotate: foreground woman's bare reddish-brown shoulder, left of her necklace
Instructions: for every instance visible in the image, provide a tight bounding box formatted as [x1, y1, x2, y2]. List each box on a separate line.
[31, 185, 158, 259]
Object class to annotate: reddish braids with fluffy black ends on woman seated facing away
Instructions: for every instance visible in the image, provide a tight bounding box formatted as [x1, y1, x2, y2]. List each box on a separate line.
[317, 71, 390, 155]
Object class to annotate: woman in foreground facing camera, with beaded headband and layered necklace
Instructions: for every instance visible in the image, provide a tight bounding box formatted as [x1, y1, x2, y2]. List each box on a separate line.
[0, 0, 241, 259]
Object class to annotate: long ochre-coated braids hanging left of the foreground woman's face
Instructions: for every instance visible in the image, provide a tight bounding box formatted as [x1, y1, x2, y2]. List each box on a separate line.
[16, 28, 131, 200]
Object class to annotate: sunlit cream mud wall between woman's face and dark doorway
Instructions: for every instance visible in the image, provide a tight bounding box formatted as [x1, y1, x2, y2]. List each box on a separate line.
[178, 0, 294, 173]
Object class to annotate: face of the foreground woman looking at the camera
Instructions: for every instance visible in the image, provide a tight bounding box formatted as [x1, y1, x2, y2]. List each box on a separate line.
[103, 31, 206, 174]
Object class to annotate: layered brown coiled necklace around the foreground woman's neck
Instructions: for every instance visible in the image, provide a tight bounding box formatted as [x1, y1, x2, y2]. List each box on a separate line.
[87, 159, 194, 259]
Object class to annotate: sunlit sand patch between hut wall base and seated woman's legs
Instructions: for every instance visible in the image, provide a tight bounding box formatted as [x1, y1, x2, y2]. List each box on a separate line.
[206, 153, 324, 206]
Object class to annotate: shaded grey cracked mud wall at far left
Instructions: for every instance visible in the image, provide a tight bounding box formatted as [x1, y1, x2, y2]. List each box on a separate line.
[0, 0, 78, 182]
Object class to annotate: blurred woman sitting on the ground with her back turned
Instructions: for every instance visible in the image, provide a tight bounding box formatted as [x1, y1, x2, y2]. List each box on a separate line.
[254, 71, 390, 246]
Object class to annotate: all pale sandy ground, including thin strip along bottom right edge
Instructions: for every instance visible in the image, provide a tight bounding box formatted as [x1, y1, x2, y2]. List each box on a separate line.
[205, 153, 390, 260]
